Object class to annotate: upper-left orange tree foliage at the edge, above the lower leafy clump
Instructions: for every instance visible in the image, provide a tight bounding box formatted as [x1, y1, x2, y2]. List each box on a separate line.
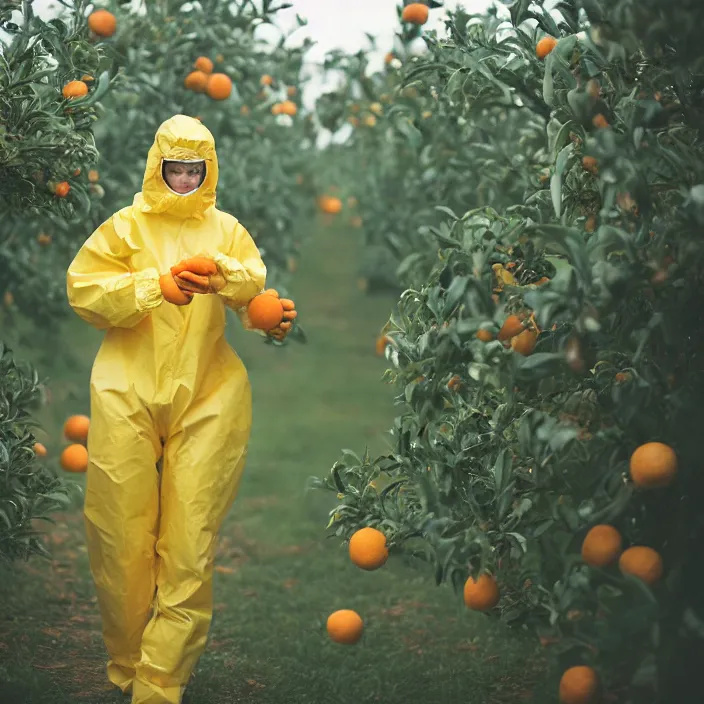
[0, 0, 109, 329]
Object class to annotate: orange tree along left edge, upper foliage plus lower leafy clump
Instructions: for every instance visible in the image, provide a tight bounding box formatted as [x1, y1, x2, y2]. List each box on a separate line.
[0, 2, 109, 561]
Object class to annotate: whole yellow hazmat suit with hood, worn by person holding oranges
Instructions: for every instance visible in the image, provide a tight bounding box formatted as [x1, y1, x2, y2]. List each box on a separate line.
[67, 115, 266, 704]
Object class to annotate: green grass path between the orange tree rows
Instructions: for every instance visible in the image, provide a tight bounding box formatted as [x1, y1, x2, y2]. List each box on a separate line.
[0, 221, 550, 704]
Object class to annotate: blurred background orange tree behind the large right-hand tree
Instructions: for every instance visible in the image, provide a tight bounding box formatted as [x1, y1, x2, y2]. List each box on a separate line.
[319, 3, 549, 286]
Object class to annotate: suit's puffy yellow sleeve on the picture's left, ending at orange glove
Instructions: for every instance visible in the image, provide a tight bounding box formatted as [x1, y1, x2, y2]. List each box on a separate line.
[66, 213, 163, 330]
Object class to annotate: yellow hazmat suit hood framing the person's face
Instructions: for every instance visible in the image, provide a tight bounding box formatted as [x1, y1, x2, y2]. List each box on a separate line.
[134, 115, 218, 220]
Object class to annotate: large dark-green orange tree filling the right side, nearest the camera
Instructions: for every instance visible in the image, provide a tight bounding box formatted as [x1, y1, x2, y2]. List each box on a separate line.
[314, 0, 704, 704]
